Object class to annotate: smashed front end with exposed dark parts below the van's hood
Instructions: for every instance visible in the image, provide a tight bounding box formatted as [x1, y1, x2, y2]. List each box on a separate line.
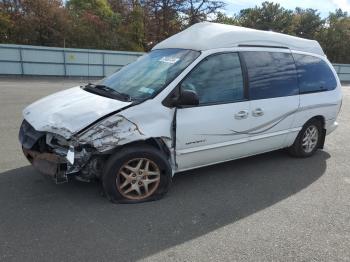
[19, 120, 104, 184]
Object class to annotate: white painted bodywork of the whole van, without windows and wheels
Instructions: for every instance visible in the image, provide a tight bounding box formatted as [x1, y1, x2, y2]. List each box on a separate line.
[23, 23, 342, 177]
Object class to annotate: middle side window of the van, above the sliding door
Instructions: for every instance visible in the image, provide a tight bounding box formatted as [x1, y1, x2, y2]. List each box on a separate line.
[242, 51, 299, 100]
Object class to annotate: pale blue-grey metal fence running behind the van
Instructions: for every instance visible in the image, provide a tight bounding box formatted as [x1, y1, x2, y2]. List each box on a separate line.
[0, 44, 350, 81]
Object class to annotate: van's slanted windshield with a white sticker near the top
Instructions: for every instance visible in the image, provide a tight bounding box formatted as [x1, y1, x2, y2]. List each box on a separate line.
[97, 49, 200, 100]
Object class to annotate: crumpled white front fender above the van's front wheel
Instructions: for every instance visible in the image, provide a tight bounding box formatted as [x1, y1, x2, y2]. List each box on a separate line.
[72, 101, 174, 156]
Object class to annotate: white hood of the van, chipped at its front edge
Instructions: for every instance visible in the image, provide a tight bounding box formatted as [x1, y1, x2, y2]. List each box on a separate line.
[23, 87, 131, 139]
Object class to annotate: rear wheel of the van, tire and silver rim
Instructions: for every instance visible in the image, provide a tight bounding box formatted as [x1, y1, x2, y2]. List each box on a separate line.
[288, 119, 322, 158]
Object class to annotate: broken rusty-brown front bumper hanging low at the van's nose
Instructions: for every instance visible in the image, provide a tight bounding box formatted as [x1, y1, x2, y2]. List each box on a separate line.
[22, 147, 68, 184]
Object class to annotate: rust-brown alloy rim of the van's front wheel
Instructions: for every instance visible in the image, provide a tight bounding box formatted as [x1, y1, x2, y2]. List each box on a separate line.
[116, 158, 160, 200]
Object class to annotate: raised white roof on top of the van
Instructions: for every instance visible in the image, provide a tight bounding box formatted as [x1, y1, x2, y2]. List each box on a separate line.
[153, 22, 324, 55]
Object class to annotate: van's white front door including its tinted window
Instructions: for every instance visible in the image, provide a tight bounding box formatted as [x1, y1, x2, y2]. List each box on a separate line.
[176, 53, 250, 171]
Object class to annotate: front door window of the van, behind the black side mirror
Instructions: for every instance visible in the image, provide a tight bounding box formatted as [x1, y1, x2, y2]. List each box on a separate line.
[181, 53, 244, 105]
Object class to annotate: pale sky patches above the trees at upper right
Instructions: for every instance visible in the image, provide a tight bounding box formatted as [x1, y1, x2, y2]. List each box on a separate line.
[224, 0, 350, 17]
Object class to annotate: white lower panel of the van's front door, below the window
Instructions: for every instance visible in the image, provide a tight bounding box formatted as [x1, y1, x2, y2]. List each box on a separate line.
[176, 102, 251, 169]
